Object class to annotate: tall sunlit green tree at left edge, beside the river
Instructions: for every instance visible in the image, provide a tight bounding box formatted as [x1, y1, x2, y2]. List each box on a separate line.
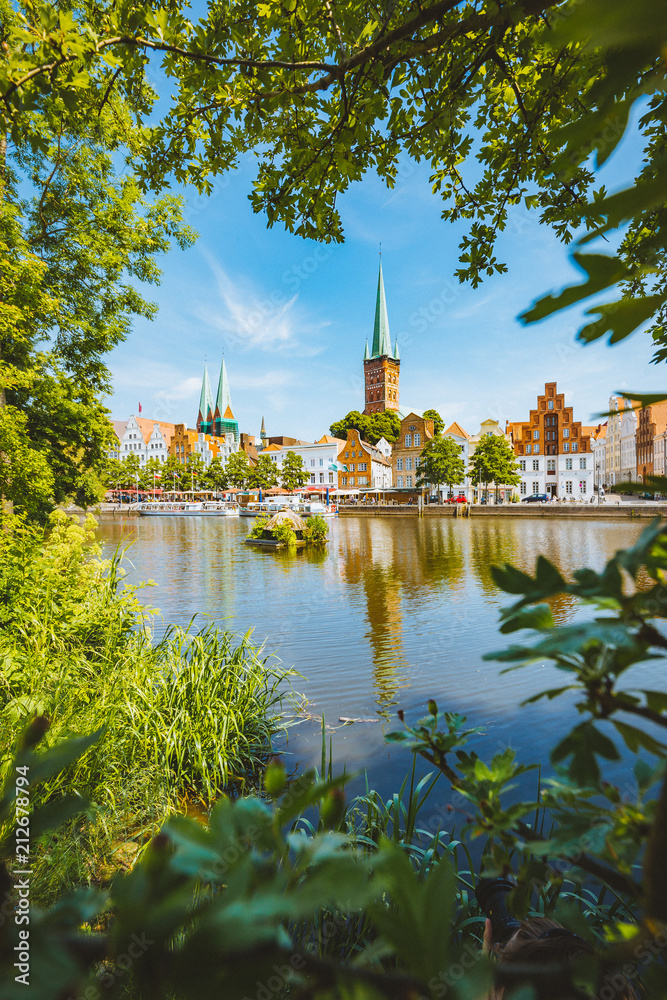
[0, 4, 193, 514]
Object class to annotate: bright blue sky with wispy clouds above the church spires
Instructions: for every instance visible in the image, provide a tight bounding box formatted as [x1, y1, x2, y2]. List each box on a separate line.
[107, 105, 665, 440]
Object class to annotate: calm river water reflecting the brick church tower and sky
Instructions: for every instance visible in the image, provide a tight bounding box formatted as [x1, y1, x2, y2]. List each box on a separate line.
[99, 516, 657, 794]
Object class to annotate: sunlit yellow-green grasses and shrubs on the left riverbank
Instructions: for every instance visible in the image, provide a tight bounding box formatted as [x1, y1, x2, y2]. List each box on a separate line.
[0, 514, 285, 902]
